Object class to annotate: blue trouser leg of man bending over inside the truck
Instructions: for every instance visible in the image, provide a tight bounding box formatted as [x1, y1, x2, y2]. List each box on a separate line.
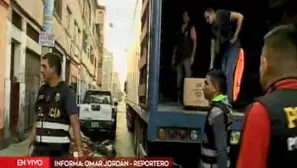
[222, 43, 240, 102]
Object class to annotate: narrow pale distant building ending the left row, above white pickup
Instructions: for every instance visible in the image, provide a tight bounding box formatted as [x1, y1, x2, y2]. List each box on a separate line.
[102, 49, 113, 91]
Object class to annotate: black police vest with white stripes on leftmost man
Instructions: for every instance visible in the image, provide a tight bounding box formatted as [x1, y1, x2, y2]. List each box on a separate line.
[35, 82, 70, 144]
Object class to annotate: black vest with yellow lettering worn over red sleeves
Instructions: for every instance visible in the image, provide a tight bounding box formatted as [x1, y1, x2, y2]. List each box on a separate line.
[255, 89, 297, 168]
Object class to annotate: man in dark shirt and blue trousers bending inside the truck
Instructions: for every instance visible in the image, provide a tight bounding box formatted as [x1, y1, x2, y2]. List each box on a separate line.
[204, 8, 243, 102]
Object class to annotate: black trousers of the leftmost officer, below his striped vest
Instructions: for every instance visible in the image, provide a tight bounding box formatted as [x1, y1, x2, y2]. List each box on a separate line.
[31, 143, 70, 157]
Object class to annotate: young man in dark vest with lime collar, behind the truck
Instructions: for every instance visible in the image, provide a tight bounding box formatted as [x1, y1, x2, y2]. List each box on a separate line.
[200, 70, 231, 168]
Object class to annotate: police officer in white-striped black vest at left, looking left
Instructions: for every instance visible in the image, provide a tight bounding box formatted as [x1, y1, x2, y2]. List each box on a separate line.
[29, 53, 83, 156]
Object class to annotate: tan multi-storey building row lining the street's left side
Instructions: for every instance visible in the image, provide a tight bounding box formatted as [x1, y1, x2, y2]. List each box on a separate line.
[0, 0, 100, 137]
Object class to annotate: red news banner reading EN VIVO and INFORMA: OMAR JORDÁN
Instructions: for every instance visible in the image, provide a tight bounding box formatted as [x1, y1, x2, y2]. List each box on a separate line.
[0, 157, 173, 168]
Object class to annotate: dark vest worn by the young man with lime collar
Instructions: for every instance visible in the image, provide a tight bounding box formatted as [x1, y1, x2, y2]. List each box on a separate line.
[201, 102, 232, 165]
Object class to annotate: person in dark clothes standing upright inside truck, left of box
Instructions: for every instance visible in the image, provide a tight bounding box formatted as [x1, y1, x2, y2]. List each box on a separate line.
[172, 11, 197, 103]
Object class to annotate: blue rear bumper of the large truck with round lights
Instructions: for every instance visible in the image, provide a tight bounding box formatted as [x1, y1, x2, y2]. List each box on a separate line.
[148, 111, 243, 143]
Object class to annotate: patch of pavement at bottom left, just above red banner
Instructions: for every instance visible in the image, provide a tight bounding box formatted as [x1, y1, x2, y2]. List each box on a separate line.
[0, 140, 28, 156]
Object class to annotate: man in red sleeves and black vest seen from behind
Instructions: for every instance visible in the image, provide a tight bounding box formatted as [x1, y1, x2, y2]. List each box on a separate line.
[237, 25, 297, 168]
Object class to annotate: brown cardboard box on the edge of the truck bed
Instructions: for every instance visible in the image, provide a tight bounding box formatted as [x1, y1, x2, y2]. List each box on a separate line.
[184, 78, 209, 107]
